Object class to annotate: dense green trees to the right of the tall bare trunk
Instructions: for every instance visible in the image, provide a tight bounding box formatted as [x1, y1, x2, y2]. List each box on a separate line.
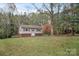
[54, 3, 79, 35]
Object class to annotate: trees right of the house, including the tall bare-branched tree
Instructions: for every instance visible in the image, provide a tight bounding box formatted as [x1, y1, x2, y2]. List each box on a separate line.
[33, 3, 79, 35]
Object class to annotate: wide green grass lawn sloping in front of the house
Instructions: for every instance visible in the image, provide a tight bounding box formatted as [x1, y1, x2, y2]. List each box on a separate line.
[0, 36, 79, 56]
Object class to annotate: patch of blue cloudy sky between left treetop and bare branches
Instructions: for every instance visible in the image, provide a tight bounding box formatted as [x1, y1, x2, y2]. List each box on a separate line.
[16, 3, 41, 13]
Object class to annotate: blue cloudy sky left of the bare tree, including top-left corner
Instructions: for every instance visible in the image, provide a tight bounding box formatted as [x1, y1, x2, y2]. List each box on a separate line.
[0, 3, 41, 13]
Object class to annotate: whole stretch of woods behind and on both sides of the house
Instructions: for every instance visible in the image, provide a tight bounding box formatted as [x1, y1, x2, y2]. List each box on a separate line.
[0, 3, 79, 38]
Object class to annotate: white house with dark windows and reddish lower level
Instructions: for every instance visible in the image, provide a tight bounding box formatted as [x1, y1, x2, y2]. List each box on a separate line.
[19, 25, 43, 37]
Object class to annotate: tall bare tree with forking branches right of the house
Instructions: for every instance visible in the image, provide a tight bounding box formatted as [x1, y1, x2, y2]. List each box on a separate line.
[32, 3, 55, 35]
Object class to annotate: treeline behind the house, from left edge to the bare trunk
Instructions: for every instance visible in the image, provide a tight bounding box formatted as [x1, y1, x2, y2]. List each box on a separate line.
[0, 4, 49, 39]
